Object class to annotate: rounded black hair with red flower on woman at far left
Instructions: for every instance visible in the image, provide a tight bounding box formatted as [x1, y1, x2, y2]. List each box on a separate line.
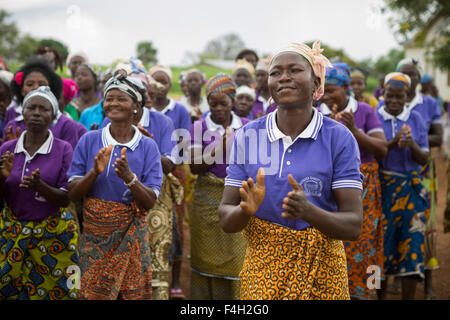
[11, 57, 63, 104]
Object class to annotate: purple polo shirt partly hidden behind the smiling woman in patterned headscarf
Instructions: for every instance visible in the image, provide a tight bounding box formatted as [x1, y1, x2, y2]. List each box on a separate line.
[102, 108, 180, 164]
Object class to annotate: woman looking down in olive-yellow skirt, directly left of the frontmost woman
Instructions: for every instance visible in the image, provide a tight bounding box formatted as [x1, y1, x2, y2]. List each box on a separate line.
[190, 73, 248, 300]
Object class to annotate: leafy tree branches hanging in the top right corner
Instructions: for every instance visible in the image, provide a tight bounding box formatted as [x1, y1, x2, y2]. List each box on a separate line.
[382, 0, 450, 69]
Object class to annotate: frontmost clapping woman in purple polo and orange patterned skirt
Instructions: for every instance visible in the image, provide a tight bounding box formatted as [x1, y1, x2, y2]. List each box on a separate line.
[219, 41, 362, 299]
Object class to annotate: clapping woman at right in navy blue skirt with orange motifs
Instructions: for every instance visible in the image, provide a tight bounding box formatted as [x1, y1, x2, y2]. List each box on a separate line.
[377, 72, 430, 300]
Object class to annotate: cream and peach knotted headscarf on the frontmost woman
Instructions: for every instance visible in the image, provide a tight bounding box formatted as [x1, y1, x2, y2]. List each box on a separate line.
[270, 40, 331, 100]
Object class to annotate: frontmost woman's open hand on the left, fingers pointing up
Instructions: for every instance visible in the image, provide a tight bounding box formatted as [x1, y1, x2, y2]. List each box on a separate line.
[239, 168, 266, 216]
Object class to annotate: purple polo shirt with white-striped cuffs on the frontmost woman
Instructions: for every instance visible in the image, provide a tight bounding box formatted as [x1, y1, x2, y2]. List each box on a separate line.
[225, 108, 363, 230]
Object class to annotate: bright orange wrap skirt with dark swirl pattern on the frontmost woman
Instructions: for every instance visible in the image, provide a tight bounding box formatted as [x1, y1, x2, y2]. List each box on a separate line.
[240, 217, 350, 300]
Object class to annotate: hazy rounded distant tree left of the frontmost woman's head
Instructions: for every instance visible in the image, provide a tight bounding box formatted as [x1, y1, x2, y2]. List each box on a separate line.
[200, 33, 245, 60]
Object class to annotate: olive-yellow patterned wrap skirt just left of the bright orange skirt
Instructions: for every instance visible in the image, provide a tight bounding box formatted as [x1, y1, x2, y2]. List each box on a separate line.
[190, 173, 247, 299]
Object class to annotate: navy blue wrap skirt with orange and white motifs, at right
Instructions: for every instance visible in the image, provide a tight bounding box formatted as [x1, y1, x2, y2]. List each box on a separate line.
[380, 170, 430, 278]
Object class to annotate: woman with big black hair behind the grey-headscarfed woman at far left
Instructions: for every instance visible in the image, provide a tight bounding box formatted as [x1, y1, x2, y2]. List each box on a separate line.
[3, 60, 87, 149]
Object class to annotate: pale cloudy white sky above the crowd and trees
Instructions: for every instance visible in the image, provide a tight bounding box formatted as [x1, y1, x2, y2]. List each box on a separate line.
[6, 0, 399, 65]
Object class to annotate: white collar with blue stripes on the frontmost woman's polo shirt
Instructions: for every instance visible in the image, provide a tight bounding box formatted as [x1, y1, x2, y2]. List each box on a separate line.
[266, 108, 323, 144]
